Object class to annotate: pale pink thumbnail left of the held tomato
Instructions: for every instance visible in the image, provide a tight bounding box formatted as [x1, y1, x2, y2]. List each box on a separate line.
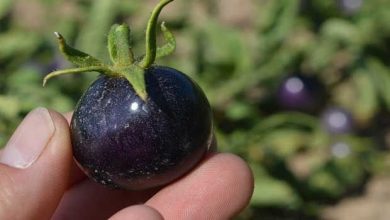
[0, 107, 55, 169]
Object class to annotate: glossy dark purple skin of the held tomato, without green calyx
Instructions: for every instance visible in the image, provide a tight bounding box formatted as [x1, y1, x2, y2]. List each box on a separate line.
[71, 66, 212, 190]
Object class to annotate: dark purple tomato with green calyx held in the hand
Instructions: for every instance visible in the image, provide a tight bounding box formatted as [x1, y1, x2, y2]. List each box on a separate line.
[43, 0, 213, 190]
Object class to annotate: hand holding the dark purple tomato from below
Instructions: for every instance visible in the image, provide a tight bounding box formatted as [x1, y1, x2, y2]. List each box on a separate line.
[0, 108, 253, 220]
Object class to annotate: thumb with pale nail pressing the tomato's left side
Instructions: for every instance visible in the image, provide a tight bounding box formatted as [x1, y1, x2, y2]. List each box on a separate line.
[0, 108, 72, 220]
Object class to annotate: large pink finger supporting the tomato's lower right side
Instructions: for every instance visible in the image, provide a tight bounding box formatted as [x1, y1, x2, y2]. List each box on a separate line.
[146, 153, 254, 219]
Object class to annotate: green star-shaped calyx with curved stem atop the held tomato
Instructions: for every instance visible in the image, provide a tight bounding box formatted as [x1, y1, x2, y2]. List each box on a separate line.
[43, 0, 176, 101]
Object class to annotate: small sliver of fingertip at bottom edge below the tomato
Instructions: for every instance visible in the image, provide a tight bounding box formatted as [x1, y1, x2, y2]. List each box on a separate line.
[109, 205, 164, 220]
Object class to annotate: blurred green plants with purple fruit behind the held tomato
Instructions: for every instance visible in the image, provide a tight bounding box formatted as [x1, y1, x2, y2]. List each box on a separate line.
[0, 0, 390, 219]
